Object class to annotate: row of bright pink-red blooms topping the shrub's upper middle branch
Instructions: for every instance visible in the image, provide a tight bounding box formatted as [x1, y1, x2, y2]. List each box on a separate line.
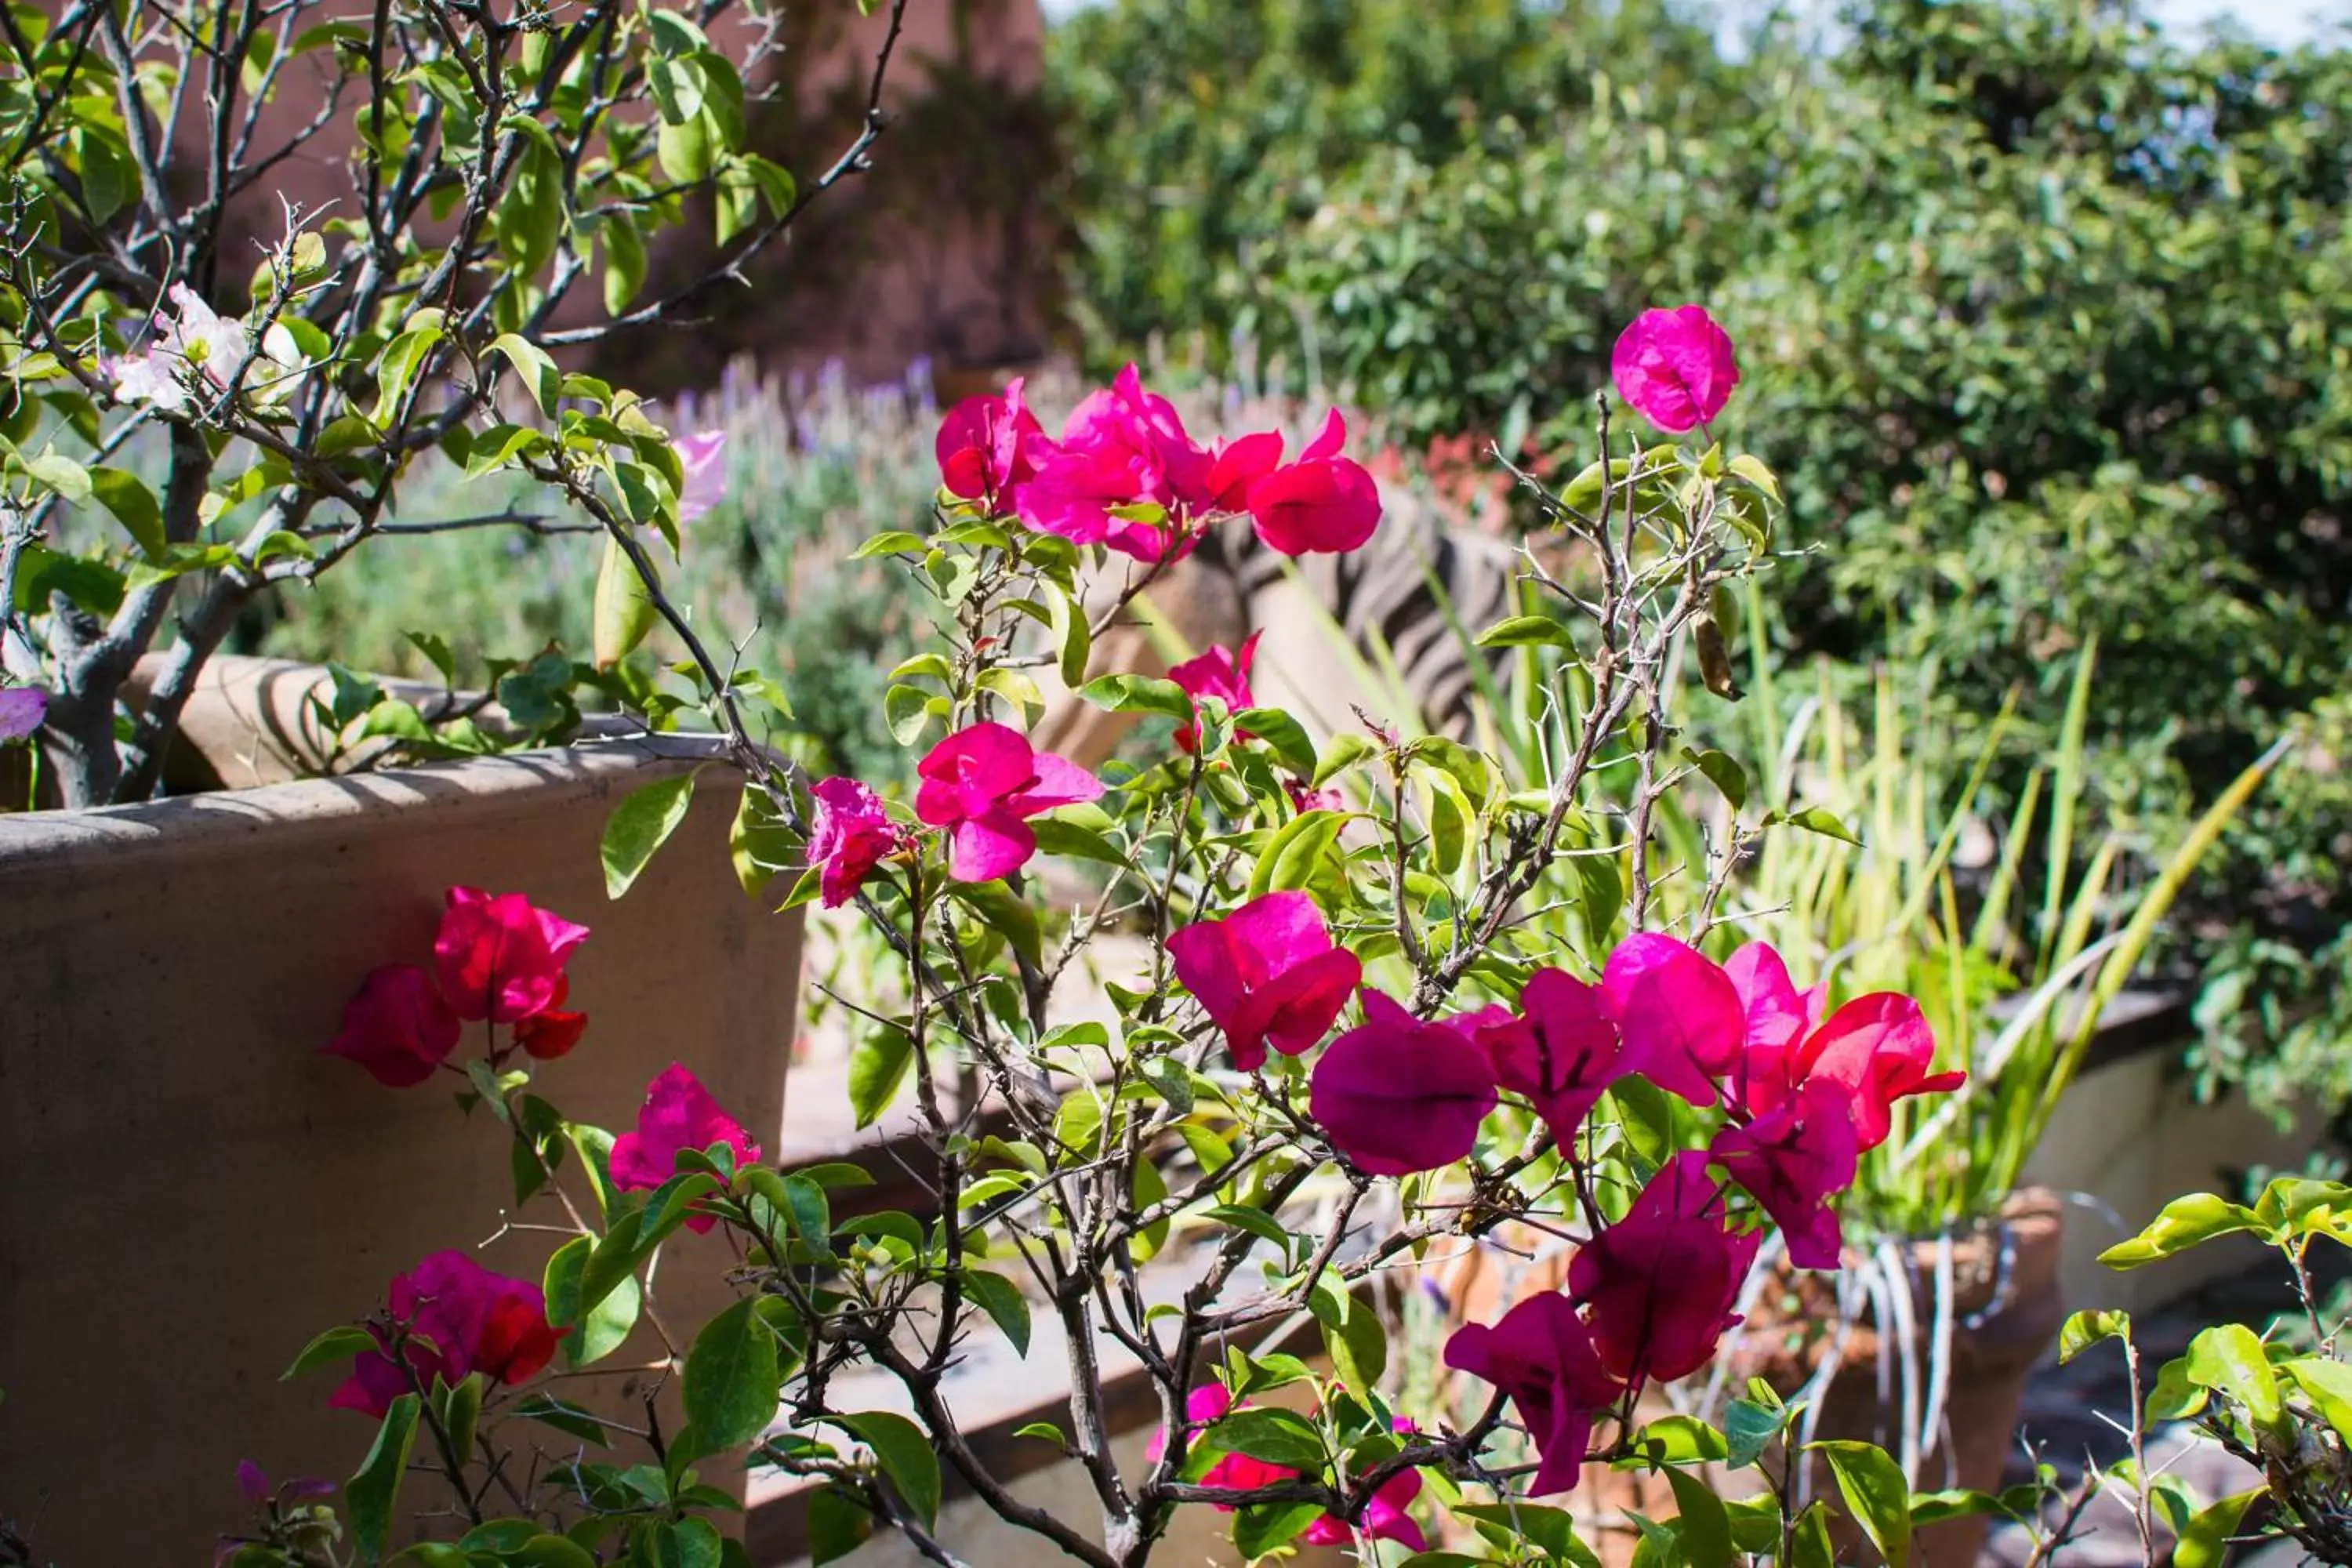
[936, 365, 1381, 562]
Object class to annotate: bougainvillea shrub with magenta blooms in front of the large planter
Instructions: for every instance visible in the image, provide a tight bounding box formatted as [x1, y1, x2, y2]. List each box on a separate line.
[247, 308, 1990, 1568]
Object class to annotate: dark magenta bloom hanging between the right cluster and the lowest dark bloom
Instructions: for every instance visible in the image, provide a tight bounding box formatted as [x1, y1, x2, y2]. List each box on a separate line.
[1569, 1149, 1764, 1382]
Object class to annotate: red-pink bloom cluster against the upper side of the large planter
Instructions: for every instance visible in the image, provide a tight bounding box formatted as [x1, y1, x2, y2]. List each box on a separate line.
[325, 886, 588, 1088]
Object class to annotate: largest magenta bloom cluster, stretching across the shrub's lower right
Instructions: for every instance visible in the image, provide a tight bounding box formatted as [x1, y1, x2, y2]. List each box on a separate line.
[1169, 893, 1964, 1495]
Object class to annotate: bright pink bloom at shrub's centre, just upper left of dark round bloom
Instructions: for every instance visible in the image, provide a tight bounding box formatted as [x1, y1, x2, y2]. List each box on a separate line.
[1169, 891, 1364, 1072]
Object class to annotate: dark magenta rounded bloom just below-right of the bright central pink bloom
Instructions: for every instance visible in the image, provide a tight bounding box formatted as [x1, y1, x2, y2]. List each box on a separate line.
[1308, 989, 1496, 1175]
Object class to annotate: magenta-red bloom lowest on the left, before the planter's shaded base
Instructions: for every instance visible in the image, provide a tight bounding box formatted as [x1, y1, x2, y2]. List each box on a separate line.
[327, 1250, 562, 1417]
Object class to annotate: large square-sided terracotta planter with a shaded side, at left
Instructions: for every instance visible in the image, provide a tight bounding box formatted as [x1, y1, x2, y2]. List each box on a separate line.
[0, 695, 800, 1563]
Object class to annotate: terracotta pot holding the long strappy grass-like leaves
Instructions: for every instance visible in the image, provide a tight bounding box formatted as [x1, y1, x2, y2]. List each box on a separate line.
[1731, 1187, 2065, 1568]
